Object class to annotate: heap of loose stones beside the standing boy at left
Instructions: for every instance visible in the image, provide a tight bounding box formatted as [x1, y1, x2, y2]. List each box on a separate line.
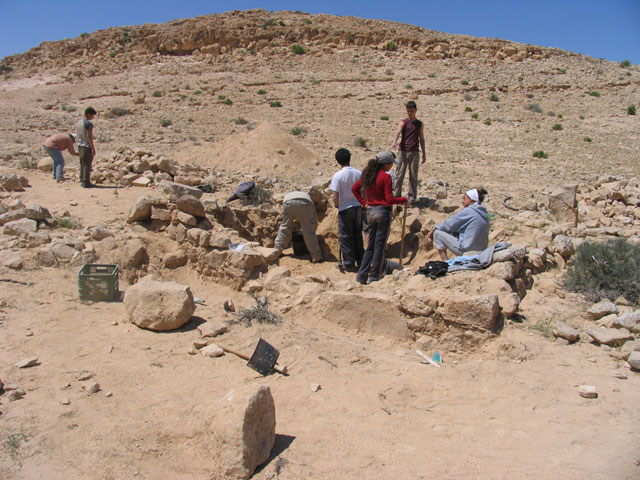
[91, 147, 215, 187]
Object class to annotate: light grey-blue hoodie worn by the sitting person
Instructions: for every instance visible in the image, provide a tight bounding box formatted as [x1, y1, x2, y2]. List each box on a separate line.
[435, 203, 489, 252]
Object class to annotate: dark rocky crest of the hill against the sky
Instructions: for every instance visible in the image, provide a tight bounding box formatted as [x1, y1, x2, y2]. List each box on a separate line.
[1, 10, 574, 76]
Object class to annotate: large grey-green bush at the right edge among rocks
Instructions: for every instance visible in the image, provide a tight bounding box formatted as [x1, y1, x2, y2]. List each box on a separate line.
[564, 238, 640, 304]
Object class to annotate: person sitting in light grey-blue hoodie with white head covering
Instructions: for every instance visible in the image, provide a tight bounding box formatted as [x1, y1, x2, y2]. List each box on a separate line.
[429, 188, 489, 261]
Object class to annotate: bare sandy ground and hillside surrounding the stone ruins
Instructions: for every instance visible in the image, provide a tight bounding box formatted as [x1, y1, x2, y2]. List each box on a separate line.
[0, 11, 640, 479]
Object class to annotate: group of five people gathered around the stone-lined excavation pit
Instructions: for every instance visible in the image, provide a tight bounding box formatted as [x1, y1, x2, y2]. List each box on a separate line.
[275, 101, 489, 284]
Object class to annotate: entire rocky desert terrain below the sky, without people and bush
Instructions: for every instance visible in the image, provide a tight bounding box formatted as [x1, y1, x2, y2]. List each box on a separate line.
[0, 10, 640, 479]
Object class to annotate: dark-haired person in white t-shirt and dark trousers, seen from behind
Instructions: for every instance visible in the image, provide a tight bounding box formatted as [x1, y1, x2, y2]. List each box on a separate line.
[329, 148, 364, 272]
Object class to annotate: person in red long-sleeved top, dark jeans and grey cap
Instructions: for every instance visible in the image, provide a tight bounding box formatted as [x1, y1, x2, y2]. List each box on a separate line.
[351, 150, 407, 284]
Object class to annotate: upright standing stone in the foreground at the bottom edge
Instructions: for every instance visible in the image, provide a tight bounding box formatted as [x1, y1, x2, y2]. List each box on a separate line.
[210, 383, 276, 479]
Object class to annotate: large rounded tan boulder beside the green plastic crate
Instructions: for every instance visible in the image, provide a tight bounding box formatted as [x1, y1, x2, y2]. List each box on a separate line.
[124, 276, 196, 330]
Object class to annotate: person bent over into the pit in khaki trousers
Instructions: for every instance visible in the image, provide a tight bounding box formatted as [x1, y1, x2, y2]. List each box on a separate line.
[275, 191, 324, 263]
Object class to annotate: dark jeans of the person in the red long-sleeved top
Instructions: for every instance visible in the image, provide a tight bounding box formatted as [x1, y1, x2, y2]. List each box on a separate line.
[356, 206, 391, 283]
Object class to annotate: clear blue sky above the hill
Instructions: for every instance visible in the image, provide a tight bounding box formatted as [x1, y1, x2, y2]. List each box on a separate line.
[0, 0, 640, 64]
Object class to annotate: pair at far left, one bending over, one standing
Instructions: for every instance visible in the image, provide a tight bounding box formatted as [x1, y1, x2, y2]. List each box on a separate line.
[42, 107, 97, 188]
